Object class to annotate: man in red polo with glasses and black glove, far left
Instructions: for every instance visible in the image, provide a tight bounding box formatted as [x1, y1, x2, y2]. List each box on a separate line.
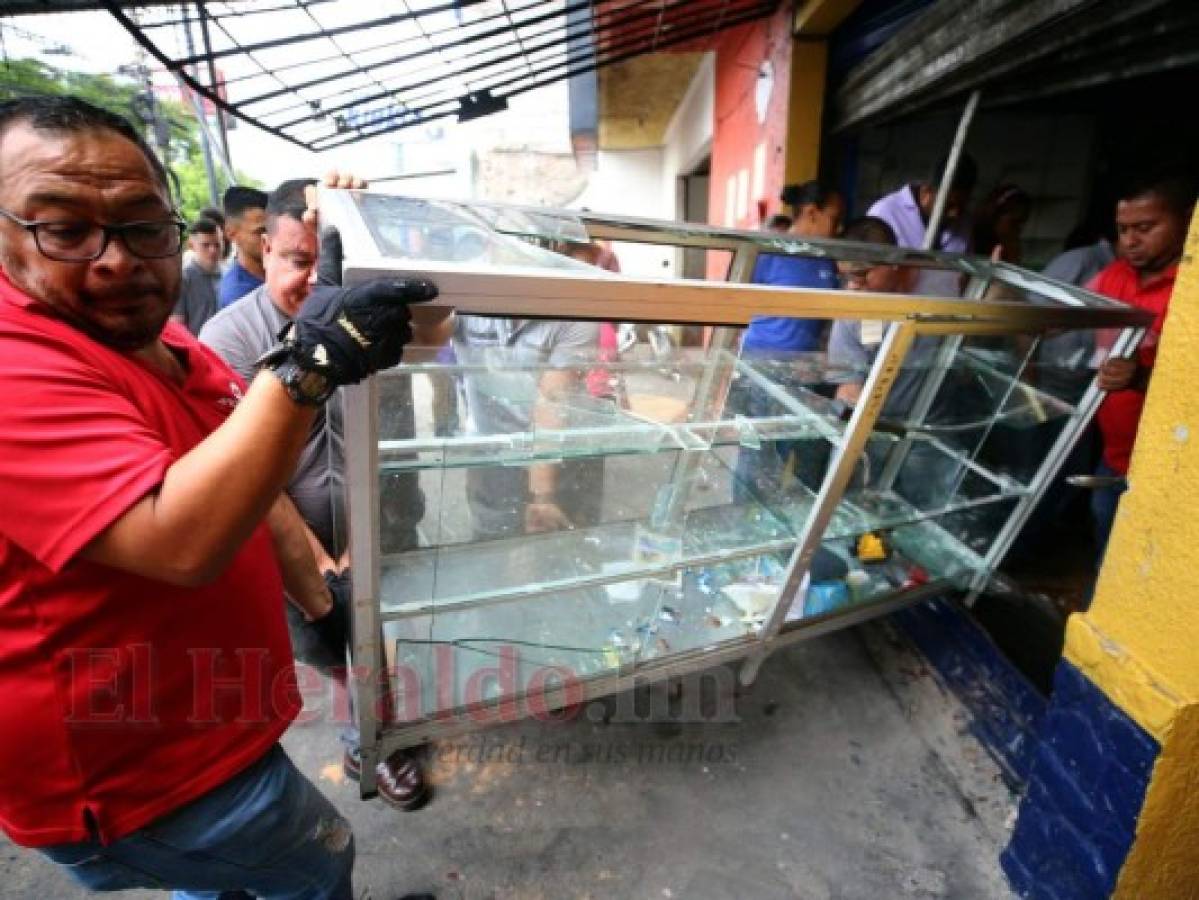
[0, 98, 435, 900]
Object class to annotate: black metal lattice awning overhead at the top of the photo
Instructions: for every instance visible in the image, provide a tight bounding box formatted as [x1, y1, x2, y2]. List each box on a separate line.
[86, 0, 778, 150]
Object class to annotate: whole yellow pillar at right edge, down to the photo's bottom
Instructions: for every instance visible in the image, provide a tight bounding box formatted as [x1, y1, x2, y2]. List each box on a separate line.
[1065, 209, 1199, 900]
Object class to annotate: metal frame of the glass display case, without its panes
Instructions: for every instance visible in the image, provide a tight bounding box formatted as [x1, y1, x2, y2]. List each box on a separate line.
[321, 191, 1149, 796]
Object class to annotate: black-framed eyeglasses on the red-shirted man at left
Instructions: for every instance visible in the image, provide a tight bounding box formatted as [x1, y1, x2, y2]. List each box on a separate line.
[0, 210, 187, 262]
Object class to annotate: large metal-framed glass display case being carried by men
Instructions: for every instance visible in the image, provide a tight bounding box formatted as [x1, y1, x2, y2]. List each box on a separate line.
[321, 191, 1147, 795]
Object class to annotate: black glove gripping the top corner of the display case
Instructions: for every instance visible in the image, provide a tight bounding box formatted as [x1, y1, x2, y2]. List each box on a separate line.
[279, 278, 438, 385]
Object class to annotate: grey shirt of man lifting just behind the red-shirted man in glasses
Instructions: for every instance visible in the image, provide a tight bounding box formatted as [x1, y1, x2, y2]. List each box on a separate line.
[199, 284, 347, 558]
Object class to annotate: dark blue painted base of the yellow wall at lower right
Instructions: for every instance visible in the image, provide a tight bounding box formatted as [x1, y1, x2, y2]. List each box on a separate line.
[892, 599, 1161, 900]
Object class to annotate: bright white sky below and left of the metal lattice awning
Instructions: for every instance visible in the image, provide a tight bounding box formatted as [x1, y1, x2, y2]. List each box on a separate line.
[0, 4, 568, 193]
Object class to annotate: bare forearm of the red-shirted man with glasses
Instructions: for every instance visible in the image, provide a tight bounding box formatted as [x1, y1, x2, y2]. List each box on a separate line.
[83, 373, 315, 585]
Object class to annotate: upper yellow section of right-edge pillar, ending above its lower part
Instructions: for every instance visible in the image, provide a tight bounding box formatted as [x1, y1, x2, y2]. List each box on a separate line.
[1066, 217, 1199, 733]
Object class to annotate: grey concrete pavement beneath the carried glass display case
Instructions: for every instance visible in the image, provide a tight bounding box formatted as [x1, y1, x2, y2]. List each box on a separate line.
[0, 623, 1014, 900]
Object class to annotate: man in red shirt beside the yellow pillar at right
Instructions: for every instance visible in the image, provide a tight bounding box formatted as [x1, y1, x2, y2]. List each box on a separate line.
[1087, 174, 1195, 561]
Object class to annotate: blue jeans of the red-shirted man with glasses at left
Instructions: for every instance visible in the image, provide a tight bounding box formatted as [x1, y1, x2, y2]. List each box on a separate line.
[41, 744, 354, 900]
